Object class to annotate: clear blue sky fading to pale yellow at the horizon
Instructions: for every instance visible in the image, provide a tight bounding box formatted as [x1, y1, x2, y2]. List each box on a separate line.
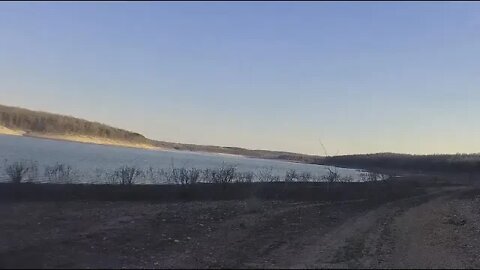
[0, 2, 480, 155]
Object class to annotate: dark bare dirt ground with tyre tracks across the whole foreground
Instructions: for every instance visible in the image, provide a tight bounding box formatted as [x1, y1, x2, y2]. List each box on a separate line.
[0, 187, 480, 268]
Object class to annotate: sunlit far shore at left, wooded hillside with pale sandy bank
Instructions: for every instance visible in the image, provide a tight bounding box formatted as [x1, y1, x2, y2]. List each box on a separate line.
[0, 105, 318, 164]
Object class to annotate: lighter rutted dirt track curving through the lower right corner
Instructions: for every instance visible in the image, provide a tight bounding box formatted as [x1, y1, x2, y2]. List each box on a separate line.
[285, 188, 480, 268]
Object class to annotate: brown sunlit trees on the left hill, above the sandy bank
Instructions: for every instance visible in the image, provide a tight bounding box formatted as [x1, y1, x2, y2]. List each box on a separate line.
[0, 105, 147, 143]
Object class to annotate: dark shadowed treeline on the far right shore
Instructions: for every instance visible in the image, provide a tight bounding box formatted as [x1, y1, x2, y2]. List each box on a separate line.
[316, 153, 480, 173]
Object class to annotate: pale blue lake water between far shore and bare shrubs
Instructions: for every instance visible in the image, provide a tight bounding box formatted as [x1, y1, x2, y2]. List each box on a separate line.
[0, 135, 361, 183]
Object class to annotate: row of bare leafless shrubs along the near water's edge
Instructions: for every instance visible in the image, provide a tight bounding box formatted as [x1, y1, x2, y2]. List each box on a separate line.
[0, 160, 364, 185]
